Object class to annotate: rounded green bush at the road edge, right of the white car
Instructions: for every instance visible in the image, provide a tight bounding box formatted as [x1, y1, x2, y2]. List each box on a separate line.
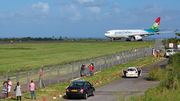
[148, 66, 167, 81]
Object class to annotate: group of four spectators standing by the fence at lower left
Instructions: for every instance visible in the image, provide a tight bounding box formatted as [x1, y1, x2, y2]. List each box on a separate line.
[2, 79, 36, 100]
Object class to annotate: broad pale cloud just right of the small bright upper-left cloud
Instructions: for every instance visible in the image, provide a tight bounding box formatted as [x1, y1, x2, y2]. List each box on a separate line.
[58, 4, 82, 21]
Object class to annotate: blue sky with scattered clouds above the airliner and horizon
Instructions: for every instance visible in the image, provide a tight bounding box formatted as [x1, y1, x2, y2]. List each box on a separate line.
[0, 0, 180, 38]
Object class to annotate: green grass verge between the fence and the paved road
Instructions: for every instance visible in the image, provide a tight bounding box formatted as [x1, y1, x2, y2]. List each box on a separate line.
[0, 53, 163, 101]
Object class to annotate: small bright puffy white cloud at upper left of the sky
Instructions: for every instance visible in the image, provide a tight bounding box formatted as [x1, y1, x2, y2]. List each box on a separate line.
[32, 2, 49, 13]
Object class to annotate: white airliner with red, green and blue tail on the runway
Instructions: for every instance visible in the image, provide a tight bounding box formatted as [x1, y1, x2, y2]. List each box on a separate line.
[105, 17, 177, 41]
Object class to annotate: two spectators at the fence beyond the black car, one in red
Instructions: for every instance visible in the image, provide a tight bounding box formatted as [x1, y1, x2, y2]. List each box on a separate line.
[81, 62, 94, 77]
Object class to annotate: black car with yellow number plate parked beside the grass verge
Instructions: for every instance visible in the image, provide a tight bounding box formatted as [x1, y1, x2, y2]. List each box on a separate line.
[66, 81, 95, 99]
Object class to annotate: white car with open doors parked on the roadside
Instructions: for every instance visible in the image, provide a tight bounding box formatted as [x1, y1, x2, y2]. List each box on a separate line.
[123, 67, 142, 78]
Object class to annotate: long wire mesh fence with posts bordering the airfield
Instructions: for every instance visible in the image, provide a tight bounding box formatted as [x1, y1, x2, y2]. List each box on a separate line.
[0, 47, 152, 97]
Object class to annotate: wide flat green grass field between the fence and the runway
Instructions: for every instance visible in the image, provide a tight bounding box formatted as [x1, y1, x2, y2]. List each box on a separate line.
[0, 42, 155, 75]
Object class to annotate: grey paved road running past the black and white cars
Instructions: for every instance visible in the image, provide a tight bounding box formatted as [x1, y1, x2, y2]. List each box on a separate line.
[66, 59, 168, 101]
